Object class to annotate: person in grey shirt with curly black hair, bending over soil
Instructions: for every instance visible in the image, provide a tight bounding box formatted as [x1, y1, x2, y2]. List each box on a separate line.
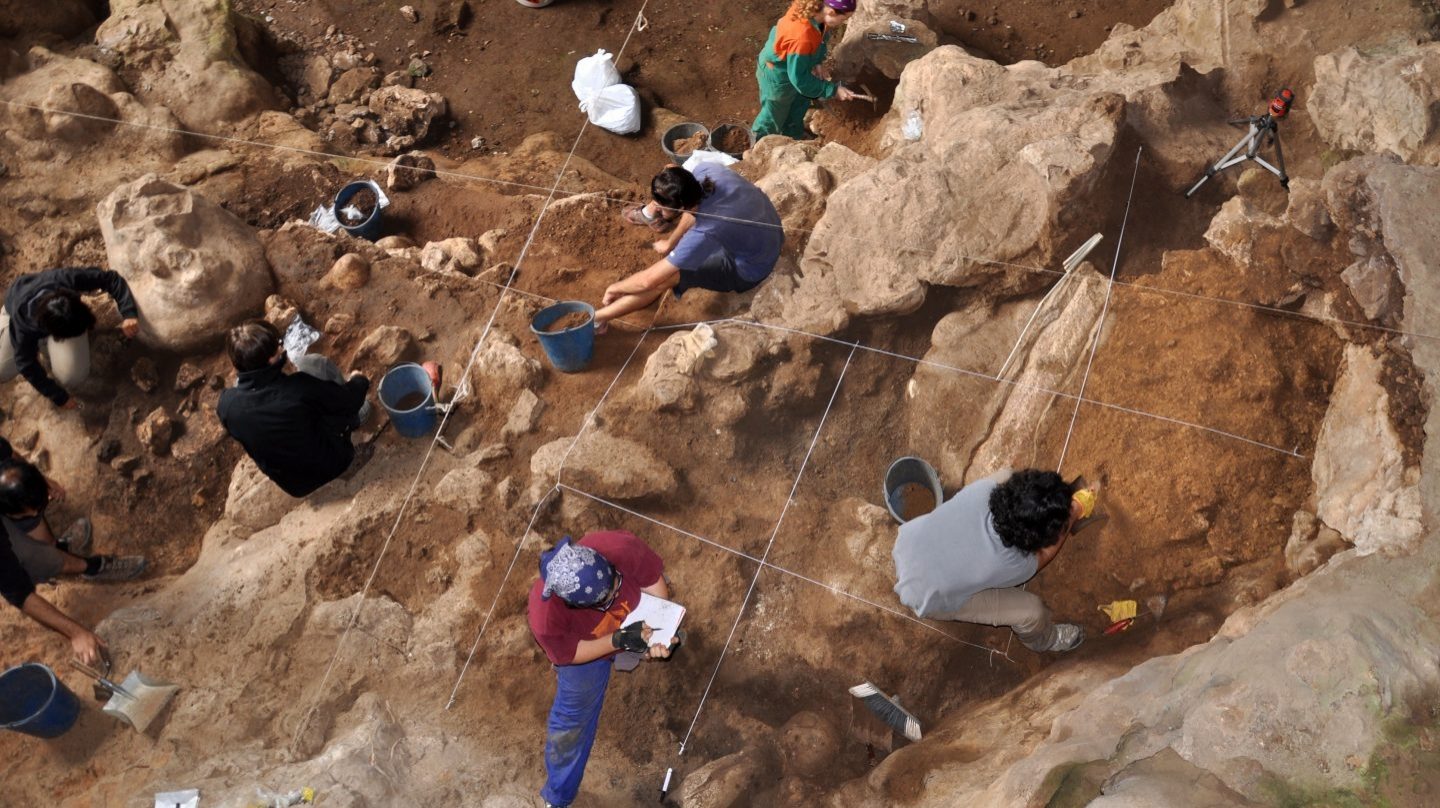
[891, 470, 1084, 651]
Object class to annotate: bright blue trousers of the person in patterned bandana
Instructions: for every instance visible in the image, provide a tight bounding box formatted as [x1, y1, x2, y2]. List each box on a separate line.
[540, 657, 613, 805]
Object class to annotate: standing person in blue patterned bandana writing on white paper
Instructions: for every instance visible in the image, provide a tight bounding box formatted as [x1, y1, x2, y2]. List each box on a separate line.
[527, 530, 674, 808]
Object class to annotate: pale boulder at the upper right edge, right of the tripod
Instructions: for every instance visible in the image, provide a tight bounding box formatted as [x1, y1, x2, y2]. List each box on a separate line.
[1308, 40, 1440, 166]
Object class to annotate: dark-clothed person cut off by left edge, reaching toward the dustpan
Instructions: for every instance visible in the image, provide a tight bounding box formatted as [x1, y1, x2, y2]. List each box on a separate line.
[0, 438, 145, 665]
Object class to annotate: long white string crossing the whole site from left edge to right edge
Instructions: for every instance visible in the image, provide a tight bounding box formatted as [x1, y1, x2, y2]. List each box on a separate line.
[0, 102, 1440, 341]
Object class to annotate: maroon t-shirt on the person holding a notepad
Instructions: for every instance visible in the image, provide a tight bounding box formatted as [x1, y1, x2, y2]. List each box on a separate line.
[528, 530, 665, 665]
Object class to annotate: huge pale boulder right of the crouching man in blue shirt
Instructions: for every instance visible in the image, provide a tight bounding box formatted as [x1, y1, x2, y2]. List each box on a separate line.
[793, 46, 1125, 333]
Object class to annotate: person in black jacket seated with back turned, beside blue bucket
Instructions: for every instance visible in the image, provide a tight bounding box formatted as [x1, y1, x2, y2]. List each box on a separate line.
[216, 320, 370, 497]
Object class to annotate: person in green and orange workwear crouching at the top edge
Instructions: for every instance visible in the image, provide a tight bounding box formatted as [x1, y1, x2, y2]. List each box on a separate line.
[750, 0, 855, 140]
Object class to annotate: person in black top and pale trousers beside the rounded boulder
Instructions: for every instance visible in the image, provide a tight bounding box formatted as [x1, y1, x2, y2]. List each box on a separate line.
[0, 266, 140, 409]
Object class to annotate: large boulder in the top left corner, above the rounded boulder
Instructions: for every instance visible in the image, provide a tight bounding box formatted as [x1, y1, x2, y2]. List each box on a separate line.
[95, 0, 281, 134]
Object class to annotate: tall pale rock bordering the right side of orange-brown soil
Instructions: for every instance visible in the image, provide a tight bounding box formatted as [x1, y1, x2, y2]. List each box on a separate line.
[1310, 339, 1421, 553]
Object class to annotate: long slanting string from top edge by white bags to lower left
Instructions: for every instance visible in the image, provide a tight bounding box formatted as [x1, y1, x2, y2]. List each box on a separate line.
[291, 0, 658, 750]
